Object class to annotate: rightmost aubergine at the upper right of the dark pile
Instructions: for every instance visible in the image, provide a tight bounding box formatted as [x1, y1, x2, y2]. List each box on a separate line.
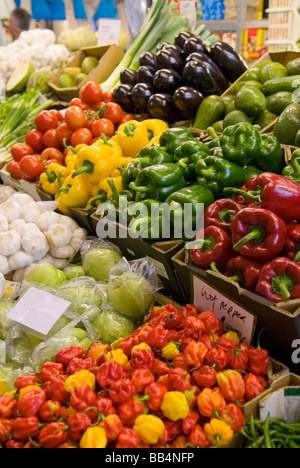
[210, 42, 248, 83]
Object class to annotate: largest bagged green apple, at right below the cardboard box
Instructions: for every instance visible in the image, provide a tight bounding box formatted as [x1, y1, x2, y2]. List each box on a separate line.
[108, 272, 155, 320]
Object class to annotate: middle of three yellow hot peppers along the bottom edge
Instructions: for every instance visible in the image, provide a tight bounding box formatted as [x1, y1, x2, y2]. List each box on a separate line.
[133, 414, 165, 445]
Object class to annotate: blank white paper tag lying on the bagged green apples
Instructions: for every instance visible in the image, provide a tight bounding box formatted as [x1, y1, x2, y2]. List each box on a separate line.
[7, 288, 71, 336]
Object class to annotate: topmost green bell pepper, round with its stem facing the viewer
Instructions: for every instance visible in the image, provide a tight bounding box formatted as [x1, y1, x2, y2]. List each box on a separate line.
[220, 122, 261, 166]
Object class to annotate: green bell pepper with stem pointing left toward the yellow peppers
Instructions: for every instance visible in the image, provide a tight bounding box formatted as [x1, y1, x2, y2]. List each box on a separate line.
[129, 163, 186, 202]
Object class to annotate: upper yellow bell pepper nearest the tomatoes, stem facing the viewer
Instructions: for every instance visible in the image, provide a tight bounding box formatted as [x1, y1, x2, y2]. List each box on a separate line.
[115, 120, 150, 158]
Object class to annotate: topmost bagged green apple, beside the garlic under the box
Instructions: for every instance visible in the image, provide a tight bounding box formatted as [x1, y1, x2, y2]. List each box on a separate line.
[83, 249, 122, 282]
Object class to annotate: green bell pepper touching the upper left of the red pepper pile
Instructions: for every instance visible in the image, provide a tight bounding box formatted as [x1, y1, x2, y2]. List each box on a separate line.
[196, 156, 246, 195]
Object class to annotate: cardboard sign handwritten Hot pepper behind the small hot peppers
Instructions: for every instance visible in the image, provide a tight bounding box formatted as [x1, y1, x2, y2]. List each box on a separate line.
[193, 276, 256, 344]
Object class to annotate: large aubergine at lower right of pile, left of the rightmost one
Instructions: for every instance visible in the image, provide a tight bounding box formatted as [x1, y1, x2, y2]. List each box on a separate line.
[182, 61, 222, 96]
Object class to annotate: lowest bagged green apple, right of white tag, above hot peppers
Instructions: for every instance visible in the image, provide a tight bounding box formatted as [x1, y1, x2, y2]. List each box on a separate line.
[93, 310, 137, 344]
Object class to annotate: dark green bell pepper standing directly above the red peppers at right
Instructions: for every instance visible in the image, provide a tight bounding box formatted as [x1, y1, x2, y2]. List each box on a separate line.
[256, 134, 284, 174]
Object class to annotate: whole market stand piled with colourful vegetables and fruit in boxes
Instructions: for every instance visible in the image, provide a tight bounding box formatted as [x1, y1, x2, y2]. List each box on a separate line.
[0, 0, 300, 454]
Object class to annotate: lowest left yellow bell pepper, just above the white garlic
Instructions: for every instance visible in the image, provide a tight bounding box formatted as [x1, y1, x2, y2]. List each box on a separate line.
[56, 175, 92, 211]
